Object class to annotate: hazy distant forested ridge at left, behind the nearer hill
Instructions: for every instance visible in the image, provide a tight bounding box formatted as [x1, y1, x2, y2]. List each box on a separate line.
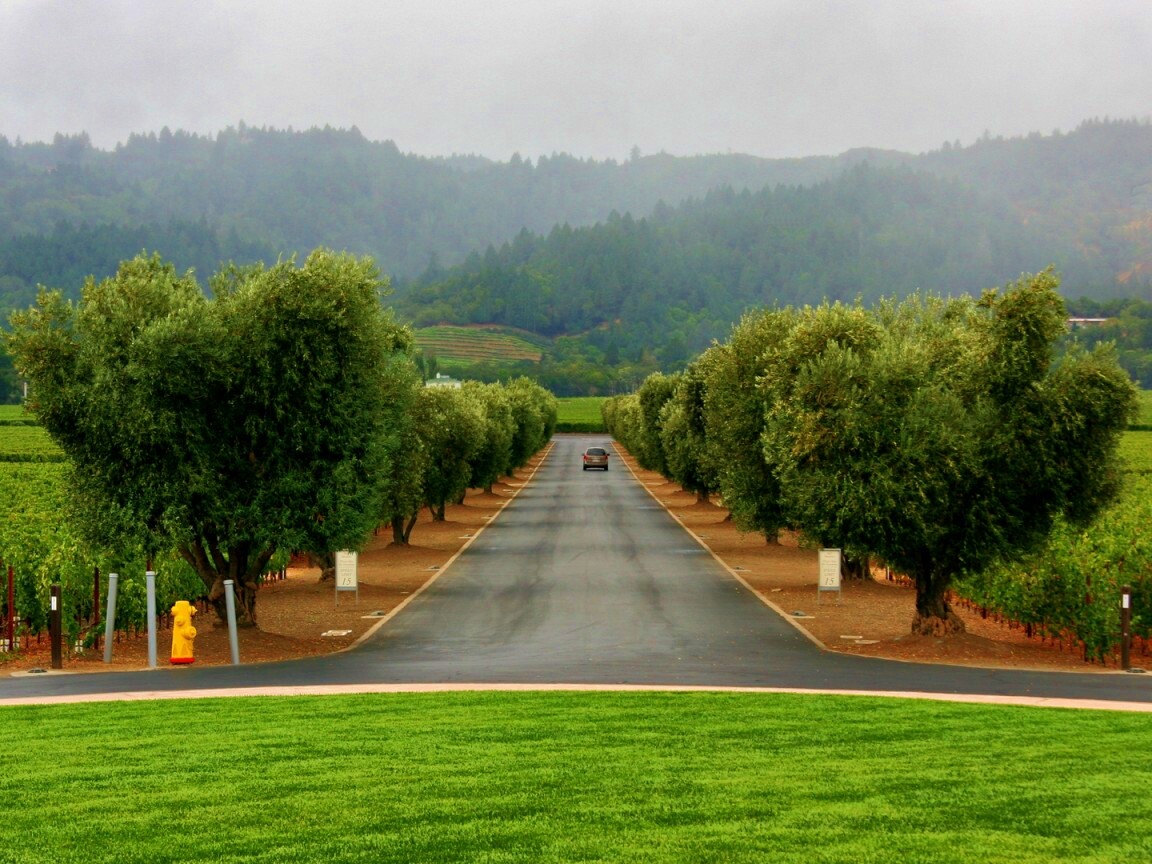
[0, 126, 866, 297]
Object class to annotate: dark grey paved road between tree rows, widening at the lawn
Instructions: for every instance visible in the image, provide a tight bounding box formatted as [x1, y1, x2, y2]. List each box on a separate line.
[0, 437, 1152, 703]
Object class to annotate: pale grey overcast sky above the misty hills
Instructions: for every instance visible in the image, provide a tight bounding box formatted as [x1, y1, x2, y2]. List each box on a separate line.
[0, 0, 1152, 160]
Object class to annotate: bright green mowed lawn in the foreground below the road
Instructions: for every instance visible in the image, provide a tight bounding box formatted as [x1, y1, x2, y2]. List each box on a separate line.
[0, 692, 1152, 864]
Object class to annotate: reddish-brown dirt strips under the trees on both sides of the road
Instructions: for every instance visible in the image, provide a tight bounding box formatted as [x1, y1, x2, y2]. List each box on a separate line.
[0, 452, 1133, 674]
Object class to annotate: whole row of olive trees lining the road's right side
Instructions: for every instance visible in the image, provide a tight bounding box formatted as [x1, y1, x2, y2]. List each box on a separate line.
[604, 271, 1137, 635]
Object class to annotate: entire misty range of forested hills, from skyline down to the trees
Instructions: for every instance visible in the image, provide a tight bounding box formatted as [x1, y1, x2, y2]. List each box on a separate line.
[0, 120, 1152, 398]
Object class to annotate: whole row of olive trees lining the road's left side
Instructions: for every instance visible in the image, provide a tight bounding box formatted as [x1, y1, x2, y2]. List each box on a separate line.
[5, 249, 556, 623]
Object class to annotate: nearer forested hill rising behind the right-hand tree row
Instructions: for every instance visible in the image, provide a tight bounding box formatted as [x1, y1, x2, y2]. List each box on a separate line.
[400, 134, 1152, 367]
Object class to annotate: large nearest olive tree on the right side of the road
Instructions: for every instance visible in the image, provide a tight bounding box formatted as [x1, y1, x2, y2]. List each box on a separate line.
[760, 272, 1135, 635]
